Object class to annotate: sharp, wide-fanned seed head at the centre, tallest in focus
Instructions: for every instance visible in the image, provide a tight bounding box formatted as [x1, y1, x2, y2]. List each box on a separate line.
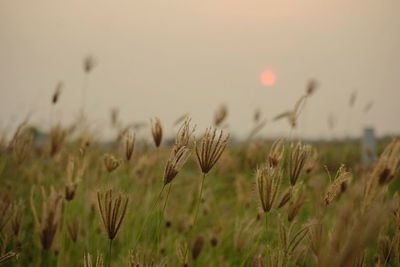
[196, 129, 229, 174]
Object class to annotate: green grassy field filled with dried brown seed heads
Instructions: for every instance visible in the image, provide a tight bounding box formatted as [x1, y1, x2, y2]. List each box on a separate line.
[0, 113, 400, 267]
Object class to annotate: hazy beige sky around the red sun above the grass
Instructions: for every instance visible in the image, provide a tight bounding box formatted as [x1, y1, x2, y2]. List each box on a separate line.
[0, 0, 400, 141]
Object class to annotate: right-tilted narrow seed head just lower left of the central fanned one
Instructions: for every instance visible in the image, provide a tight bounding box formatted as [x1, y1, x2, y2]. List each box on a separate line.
[164, 146, 190, 186]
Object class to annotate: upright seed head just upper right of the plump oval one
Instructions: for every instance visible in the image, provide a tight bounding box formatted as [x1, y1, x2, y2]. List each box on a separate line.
[288, 143, 311, 186]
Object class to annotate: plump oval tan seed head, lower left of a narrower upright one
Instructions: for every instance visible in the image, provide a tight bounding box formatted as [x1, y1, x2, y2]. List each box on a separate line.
[256, 166, 282, 213]
